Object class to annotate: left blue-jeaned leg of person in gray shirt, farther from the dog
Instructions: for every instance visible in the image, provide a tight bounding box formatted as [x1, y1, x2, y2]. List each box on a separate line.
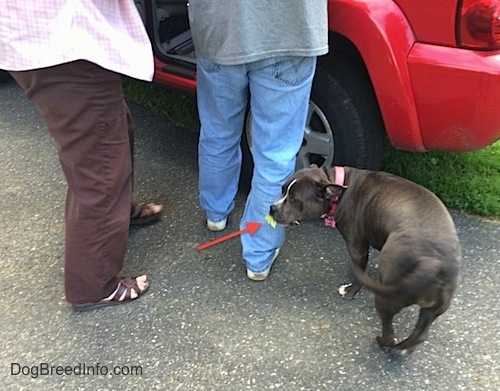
[197, 57, 248, 226]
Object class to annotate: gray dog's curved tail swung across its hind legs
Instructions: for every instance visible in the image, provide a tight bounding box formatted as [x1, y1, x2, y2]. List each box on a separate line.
[351, 257, 441, 296]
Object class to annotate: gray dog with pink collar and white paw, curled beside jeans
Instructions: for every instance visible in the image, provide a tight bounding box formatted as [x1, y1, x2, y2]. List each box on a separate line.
[270, 165, 461, 355]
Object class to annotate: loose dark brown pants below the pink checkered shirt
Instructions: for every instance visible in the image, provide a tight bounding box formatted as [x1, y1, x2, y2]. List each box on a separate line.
[12, 61, 132, 304]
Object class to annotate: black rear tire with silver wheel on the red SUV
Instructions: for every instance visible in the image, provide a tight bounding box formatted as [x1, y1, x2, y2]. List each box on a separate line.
[240, 57, 385, 191]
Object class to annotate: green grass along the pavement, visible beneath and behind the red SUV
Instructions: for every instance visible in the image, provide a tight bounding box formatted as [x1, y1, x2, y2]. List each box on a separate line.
[124, 79, 500, 219]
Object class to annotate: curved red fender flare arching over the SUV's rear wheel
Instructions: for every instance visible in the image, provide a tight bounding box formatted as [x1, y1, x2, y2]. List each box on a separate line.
[328, 0, 425, 151]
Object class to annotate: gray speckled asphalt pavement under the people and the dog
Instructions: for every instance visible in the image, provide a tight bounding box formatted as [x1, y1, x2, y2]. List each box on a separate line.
[0, 82, 500, 391]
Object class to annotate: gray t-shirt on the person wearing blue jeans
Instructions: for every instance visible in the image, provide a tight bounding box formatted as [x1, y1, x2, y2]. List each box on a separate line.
[188, 0, 328, 65]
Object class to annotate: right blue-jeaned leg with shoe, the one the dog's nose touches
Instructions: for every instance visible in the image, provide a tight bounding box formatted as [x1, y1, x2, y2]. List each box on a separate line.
[241, 57, 316, 280]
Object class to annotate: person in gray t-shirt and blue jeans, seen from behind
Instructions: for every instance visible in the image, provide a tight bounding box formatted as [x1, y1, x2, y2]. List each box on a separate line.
[188, 0, 328, 281]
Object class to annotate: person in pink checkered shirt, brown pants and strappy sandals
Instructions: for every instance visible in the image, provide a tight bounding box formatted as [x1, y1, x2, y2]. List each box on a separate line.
[0, 0, 163, 311]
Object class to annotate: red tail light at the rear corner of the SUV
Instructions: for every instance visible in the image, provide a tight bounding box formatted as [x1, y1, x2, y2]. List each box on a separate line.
[457, 0, 500, 50]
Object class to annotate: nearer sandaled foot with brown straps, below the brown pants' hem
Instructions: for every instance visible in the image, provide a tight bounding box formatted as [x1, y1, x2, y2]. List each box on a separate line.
[73, 275, 149, 311]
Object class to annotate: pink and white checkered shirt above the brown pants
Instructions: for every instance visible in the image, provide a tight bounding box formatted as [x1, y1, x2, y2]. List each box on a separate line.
[0, 0, 153, 80]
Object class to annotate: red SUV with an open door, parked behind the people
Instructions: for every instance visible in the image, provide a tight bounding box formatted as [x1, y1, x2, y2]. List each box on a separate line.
[136, 0, 500, 168]
